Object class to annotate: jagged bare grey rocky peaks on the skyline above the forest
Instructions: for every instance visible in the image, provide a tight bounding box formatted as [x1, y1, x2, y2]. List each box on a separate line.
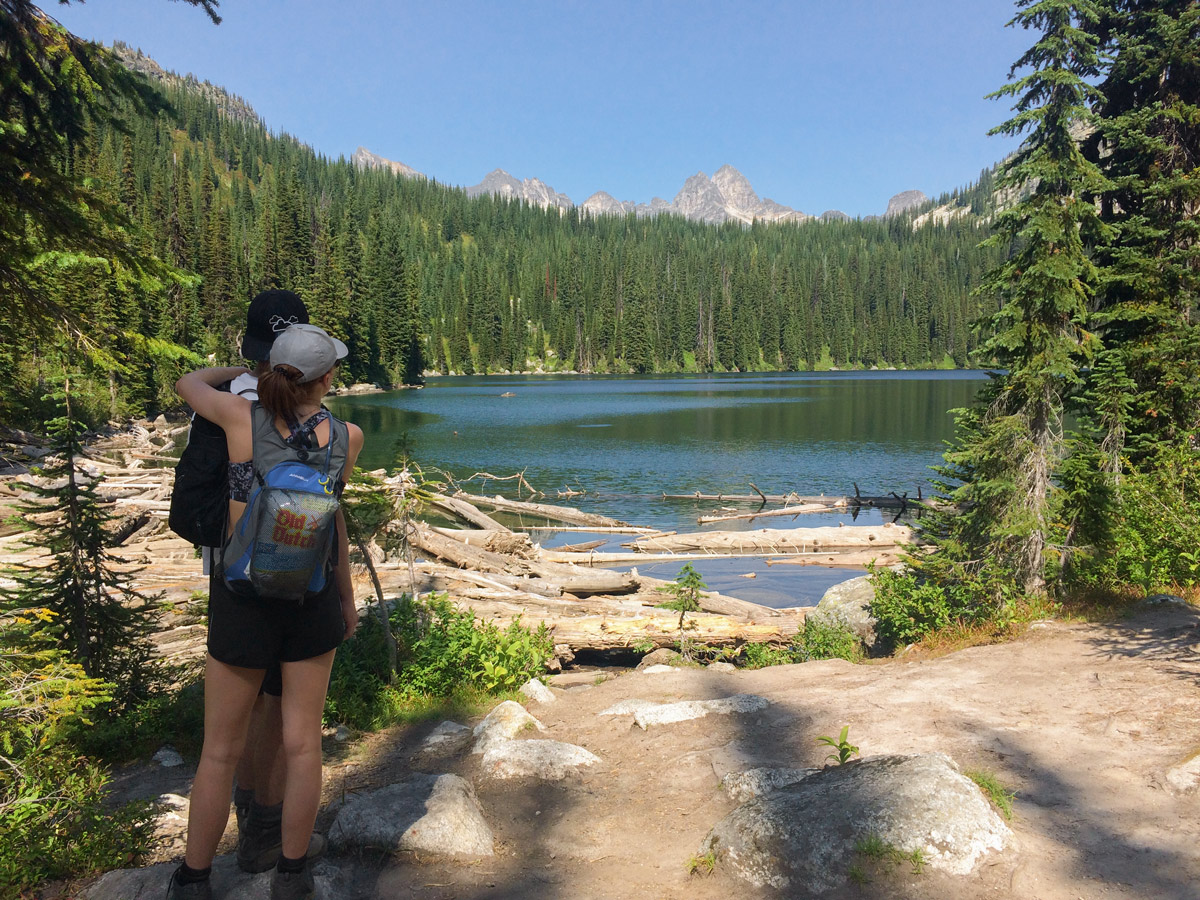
[350, 146, 929, 224]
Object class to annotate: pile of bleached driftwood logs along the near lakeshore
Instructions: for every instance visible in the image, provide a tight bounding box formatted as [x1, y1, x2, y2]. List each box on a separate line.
[0, 419, 912, 662]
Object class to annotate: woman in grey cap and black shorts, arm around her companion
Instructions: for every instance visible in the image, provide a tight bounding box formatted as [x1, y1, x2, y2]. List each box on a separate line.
[170, 325, 362, 900]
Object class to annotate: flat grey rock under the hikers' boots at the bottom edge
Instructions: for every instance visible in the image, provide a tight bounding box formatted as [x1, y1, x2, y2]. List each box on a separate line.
[80, 853, 350, 900]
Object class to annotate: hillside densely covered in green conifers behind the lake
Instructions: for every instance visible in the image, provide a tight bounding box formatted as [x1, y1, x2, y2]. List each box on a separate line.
[5, 38, 998, 420]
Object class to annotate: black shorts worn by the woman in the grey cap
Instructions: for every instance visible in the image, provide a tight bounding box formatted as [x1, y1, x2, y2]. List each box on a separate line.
[209, 576, 346, 676]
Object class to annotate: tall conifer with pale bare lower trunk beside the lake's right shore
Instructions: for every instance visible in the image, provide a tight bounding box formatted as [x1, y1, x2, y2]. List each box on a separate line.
[937, 0, 1103, 595]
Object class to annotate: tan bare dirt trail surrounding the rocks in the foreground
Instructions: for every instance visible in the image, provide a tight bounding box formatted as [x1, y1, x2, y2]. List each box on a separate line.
[100, 606, 1200, 900]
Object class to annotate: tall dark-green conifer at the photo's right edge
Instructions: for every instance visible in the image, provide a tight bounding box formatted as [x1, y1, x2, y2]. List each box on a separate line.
[1090, 0, 1200, 463]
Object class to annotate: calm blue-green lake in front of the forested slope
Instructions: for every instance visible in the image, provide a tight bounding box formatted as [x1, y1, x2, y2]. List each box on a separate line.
[329, 371, 985, 606]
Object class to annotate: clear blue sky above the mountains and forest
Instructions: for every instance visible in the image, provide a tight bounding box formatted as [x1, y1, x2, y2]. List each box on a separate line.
[51, 0, 1032, 216]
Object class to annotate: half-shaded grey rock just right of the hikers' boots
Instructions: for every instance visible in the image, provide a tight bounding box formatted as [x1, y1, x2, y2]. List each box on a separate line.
[329, 773, 494, 857]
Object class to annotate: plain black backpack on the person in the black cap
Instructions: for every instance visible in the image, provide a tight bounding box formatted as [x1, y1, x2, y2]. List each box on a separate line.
[167, 382, 229, 547]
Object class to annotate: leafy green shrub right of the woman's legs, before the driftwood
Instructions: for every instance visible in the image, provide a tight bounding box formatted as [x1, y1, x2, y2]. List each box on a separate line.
[325, 595, 553, 728]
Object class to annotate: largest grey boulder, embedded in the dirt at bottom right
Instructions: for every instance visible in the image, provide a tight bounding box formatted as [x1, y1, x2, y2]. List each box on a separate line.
[700, 754, 1012, 894]
